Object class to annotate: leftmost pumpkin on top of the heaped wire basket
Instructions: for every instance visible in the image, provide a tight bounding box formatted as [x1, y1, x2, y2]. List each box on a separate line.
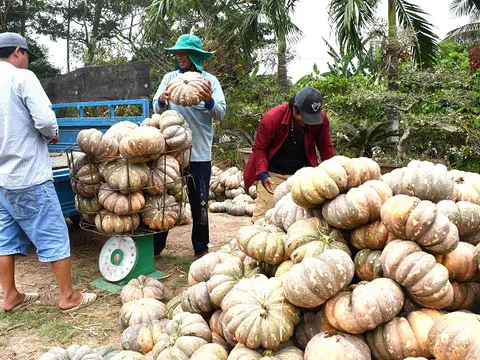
[77, 129, 118, 162]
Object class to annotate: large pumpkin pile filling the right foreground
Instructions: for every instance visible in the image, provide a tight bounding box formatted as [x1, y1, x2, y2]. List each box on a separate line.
[42, 156, 480, 360]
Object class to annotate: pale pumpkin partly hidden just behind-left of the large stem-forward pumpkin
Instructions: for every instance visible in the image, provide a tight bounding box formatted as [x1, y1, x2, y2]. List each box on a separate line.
[207, 258, 263, 307]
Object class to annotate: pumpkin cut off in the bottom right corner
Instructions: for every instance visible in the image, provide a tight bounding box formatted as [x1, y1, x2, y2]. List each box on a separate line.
[428, 312, 480, 360]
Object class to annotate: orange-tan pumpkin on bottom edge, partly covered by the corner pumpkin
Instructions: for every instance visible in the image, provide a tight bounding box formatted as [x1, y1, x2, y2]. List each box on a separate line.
[366, 308, 445, 360]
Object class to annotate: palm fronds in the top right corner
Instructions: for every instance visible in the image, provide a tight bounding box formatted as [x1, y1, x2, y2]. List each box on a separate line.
[447, 0, 480, 42]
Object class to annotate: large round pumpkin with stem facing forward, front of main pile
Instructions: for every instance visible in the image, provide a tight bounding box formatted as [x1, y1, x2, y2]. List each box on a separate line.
[222, 275, 300, 350]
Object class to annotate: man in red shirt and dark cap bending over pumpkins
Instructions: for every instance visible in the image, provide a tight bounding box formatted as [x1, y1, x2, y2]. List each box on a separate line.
[243, 87, 334, 221]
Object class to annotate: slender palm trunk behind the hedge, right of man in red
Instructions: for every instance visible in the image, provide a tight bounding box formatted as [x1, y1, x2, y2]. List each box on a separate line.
[387, 0, 400, 142]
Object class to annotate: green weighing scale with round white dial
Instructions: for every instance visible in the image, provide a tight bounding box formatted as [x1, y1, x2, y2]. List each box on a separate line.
[92, 235, 165, 294]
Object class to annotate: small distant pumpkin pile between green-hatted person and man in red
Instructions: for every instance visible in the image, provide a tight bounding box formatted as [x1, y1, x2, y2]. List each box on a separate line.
[208, 166, 257, 216]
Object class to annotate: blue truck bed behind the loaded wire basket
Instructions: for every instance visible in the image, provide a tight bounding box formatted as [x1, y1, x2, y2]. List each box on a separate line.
[48, 99, 150, 217]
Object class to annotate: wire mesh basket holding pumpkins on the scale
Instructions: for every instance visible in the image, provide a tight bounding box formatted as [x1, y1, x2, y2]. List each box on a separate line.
[66, 145, 191, 236]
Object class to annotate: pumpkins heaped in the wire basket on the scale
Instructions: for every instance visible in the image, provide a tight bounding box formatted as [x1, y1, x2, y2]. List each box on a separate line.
[69, 110, 192, 235]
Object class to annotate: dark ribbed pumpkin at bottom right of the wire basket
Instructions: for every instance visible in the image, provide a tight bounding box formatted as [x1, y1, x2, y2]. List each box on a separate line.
[142, 195, 180, 230]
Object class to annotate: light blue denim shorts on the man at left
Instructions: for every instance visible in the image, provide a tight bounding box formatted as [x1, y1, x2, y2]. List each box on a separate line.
[0, 180, 70, 262]
